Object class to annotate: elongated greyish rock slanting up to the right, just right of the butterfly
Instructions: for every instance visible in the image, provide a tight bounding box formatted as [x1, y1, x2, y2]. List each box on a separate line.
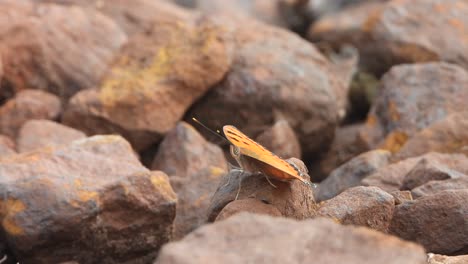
[314, 150, 390, 202]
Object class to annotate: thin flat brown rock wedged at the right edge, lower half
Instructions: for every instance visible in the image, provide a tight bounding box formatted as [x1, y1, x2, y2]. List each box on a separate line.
[411, 175, 468, 199]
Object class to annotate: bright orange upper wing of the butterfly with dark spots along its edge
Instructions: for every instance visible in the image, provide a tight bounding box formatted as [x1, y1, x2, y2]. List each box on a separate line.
[223, 125, 302, 179]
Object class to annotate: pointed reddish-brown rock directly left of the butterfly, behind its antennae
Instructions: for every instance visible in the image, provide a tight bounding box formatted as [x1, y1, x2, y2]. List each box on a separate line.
[151, 122, 228, 177]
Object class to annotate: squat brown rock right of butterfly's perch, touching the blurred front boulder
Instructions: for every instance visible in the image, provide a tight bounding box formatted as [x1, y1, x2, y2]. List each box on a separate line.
[317, 186, 395, 232]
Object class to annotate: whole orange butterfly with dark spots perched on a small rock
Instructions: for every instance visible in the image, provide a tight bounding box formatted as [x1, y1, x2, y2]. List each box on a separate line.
[223, 125, 312, 186]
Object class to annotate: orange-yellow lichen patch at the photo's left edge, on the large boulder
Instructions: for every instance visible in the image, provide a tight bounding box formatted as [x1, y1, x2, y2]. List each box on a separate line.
[0, 199, 26, 236]
